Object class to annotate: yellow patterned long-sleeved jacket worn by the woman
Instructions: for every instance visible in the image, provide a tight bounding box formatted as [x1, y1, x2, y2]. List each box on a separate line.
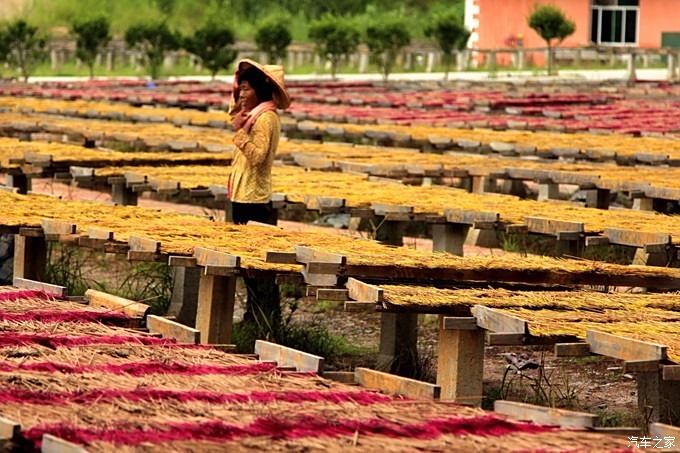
[229, 112, 281, 203]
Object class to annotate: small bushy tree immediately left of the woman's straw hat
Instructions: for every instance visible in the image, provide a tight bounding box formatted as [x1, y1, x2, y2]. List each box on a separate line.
[184, 22, 237, 79]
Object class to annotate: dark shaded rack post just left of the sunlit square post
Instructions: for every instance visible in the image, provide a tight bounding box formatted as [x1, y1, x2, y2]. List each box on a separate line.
[377, 313, 418, 377]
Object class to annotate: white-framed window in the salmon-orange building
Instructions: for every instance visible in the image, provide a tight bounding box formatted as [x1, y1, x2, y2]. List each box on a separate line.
[590, 0, 640, 45]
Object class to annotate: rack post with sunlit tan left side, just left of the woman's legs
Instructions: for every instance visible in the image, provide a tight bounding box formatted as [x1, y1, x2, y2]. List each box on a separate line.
[196, 275, 236, 344]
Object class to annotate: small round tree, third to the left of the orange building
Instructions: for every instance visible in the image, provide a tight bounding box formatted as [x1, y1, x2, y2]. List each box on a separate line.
[309, 16, 360, 78]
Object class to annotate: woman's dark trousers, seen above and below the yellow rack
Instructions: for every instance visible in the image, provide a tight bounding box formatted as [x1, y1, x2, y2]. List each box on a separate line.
[231, 202, 281, 332]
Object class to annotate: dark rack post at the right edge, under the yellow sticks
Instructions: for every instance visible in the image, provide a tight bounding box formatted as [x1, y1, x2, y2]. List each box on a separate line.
[635, 371, 680, 425]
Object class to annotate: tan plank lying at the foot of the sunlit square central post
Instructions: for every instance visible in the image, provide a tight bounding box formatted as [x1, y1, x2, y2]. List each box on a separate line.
[354, 368, 441, 400]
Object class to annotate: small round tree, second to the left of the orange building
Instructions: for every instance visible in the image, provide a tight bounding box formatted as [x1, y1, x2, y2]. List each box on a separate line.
[366, 19, 411, 81]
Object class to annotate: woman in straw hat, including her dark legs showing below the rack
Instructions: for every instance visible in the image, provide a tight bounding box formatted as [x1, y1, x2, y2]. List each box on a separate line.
[229, 60, 290, 342]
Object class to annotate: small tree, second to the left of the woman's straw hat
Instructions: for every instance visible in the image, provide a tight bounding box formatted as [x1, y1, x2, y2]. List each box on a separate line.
[125, 22, 181, 79]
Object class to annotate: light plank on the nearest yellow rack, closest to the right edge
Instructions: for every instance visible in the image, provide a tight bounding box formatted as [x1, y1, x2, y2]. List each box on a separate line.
[586, 330, 668, 360]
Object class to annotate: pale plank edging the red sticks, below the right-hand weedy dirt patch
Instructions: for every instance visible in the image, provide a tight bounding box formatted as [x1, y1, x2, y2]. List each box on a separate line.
[494, 400, 598, 428]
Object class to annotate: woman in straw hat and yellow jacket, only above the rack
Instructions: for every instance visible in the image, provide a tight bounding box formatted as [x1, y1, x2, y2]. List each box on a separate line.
[229, 59, 290, 224]
